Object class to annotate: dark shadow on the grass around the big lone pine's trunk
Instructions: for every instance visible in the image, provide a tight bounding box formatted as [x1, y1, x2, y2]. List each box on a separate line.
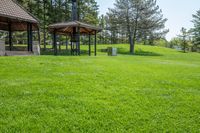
[99, 48, 163, 56]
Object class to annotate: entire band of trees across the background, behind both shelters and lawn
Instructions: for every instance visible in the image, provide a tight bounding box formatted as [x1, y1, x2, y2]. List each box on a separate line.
[1, 0, 200, 54]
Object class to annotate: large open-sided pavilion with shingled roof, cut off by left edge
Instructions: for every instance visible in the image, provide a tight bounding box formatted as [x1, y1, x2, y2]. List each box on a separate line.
[0, 0, 40, 55]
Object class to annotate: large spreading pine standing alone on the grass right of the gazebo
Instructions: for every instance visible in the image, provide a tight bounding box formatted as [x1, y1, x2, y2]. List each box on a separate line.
[107, 0, 168, 53]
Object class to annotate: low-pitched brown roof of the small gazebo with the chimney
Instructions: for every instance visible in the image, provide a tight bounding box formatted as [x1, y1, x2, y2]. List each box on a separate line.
[49, 21, 101, 35]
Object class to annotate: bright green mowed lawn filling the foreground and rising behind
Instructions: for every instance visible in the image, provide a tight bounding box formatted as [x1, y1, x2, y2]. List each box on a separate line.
[0, 45, 200, 133]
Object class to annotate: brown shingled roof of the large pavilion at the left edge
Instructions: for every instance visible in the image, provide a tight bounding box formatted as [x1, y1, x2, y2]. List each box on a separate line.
[0, 0, 39, 31]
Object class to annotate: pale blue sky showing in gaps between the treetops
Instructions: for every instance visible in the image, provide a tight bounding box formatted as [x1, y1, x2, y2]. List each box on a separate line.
[96, 0, 200, 40]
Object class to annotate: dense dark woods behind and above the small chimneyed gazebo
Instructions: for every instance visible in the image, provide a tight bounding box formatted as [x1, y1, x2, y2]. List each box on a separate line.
[17, 0, 99, 48]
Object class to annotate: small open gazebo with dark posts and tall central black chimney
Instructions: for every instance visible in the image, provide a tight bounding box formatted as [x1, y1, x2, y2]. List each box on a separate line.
[49, 0, 101, 56]
